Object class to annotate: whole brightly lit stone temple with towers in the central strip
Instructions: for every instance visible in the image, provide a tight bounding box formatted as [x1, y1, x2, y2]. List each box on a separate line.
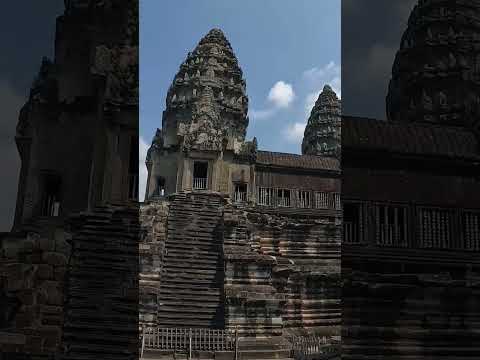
[140, 29, 342, 357]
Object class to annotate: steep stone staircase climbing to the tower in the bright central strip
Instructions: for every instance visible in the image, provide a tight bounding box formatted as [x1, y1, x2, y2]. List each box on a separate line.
[157, 192, 224, 328]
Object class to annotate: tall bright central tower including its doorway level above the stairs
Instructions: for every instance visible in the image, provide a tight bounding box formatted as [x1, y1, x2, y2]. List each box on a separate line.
[146, 29, 253, 198]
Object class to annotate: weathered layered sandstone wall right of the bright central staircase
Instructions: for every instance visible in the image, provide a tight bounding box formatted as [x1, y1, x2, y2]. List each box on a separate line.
[224, 205, 341, 336]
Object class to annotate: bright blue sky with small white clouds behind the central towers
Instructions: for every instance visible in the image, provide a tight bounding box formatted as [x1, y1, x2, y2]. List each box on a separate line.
[140, 0, 341, 197]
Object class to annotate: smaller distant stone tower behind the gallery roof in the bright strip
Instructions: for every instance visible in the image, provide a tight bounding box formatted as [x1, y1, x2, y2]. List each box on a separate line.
[302, 85, 341, 158]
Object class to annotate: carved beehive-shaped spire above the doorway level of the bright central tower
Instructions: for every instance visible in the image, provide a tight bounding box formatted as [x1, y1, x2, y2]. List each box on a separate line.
[162, 29, 248, 151]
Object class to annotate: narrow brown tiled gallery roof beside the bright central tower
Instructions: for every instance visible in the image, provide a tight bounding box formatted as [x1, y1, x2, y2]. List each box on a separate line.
[257, 151, 340, 171]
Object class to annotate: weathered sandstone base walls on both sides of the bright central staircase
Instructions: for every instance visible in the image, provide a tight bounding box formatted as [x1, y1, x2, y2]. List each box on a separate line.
[140, 195, 341, 344]
